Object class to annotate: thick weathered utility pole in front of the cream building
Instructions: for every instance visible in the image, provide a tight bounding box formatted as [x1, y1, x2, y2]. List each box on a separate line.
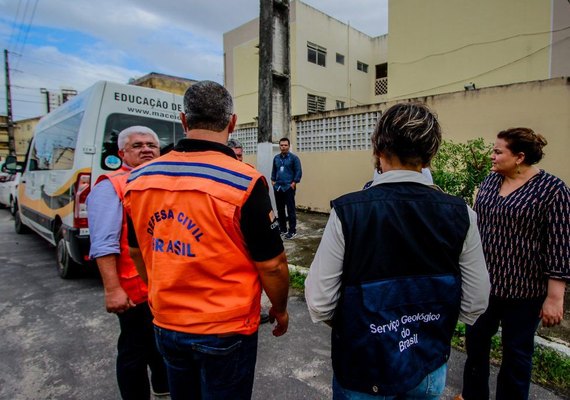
[257, 0, 291, 206]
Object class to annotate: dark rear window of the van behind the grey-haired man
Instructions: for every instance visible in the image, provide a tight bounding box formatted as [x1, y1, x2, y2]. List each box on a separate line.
[101, 113, 184, 170]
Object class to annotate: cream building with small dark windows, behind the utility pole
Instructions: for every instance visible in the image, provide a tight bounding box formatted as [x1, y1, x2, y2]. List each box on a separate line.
[224, 0, 387, 124]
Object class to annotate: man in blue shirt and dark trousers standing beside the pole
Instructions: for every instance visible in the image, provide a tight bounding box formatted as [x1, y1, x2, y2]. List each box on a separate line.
[271, 137, 303, 239]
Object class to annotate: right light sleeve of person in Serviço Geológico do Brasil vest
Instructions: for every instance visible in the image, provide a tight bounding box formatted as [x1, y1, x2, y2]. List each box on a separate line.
[459, 207, 491, 325]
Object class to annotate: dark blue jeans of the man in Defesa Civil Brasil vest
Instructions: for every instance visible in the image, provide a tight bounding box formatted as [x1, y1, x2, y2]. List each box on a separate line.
[155, 326, 257, 400]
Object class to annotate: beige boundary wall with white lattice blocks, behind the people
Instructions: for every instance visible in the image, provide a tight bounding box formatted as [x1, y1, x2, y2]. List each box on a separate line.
[236, 78, 570, 212]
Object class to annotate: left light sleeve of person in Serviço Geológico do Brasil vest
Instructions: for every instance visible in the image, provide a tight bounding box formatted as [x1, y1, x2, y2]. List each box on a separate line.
[305, 209, 344, 322]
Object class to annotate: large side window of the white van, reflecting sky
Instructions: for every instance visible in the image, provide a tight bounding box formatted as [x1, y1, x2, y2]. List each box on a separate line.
[30, 112, 83, 170]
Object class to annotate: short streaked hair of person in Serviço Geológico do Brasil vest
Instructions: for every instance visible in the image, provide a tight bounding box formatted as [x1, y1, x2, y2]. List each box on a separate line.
[372, 103, 441, 166]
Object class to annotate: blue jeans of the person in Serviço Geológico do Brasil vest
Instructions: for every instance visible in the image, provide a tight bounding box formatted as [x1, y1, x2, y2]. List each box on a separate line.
[333, 363, 447, 400]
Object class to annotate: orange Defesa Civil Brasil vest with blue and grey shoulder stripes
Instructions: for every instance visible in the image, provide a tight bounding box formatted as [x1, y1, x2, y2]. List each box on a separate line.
[125, 151, 264, 335]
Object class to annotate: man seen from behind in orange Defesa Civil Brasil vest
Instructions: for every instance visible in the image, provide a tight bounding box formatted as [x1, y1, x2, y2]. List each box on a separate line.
[124, 81, 289, 400]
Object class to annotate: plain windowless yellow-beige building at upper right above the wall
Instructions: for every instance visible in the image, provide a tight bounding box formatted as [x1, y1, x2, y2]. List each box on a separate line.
[388, 0, 570, 100]
